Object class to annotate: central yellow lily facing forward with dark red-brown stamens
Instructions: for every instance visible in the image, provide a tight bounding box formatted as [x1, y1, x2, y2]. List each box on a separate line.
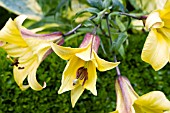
[51, 33, 119, 107]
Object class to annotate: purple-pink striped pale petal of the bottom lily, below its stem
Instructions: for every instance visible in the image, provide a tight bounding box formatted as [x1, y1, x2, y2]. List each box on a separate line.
[115, 76, 138, 113]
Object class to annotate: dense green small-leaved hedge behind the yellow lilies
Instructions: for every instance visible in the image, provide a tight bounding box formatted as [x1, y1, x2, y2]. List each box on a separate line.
[0, 0, 170, 113]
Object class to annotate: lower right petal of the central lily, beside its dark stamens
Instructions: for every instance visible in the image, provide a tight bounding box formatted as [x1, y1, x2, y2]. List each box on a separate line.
[84, 61, 97, 96]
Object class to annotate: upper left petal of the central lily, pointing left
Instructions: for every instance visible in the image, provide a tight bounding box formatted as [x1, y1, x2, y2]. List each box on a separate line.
[51, 43, 85, 60]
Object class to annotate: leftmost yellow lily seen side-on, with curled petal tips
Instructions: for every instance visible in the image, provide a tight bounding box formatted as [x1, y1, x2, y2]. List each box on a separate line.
[0, 15, 62, 90]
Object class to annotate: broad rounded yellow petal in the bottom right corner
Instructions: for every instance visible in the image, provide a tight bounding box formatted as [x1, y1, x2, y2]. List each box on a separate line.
[135, 91, 170, 113]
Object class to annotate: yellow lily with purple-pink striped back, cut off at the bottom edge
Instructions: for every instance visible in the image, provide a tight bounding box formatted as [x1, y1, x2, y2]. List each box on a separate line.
[112, 76, 170, 113]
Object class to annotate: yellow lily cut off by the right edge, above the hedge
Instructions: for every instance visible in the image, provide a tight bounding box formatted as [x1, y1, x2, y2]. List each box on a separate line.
[141, 0, 170, 71]
